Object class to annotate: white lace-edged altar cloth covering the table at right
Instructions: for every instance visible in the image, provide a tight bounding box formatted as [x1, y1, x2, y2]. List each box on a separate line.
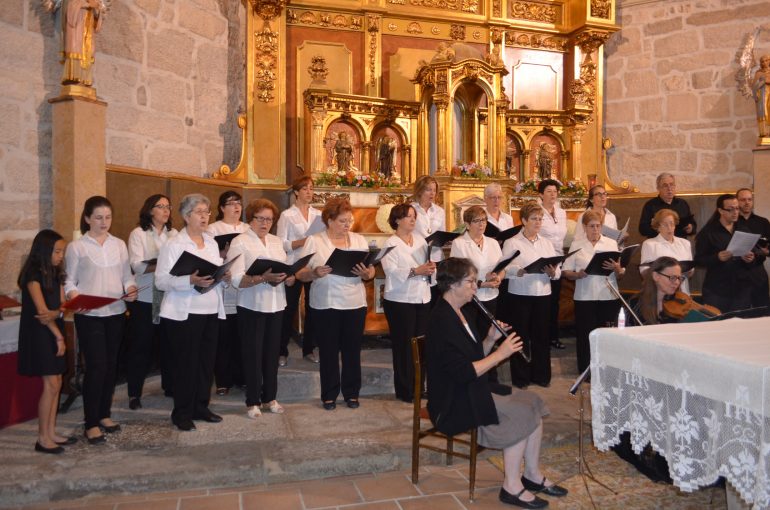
[591, 318, 770, 508]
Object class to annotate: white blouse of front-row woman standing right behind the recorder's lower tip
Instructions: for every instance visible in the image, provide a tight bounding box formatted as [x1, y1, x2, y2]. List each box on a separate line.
[503, 230, 562, 296]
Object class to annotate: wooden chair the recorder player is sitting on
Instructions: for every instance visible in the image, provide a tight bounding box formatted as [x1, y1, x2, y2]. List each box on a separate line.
[412, 336, 484, 502]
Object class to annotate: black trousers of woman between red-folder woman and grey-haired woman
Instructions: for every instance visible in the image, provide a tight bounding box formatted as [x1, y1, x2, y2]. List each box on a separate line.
[126, 301, 173, 398]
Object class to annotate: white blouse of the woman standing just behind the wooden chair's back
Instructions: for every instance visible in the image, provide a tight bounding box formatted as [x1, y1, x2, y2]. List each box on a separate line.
[382, 234, 430, 303]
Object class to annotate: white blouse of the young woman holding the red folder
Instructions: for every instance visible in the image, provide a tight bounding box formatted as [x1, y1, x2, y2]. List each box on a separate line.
[64, 232, 136, 317]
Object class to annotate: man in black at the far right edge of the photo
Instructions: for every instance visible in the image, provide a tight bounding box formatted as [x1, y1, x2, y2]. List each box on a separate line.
[735, 188, 770, 315]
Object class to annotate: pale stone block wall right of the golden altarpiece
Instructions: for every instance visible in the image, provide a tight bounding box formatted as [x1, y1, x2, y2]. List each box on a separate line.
[605, 0, 770, 191]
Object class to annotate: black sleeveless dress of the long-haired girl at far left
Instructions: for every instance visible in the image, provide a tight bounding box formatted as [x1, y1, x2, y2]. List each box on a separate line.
[18, 271, 67, 376]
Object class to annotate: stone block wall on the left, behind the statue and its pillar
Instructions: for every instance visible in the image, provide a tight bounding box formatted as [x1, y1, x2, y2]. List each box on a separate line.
[0, 0, 244, 293]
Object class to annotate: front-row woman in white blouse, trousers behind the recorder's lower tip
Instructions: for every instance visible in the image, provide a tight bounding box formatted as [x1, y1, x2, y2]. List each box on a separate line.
[503, 202, 561, 388]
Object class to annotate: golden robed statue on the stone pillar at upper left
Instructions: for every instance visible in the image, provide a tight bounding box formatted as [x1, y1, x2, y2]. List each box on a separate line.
[42, 0, 107, 91]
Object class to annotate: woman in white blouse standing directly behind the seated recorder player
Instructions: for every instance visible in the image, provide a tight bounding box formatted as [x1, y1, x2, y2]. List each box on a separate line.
[449, 205, 505, 331]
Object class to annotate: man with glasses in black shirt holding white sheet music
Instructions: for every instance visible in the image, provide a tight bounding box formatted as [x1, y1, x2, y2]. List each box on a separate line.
[695, 194, 755, 313]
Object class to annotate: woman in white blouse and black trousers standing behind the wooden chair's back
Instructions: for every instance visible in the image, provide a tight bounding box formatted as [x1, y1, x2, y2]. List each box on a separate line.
[382, 204, 436, 402]
